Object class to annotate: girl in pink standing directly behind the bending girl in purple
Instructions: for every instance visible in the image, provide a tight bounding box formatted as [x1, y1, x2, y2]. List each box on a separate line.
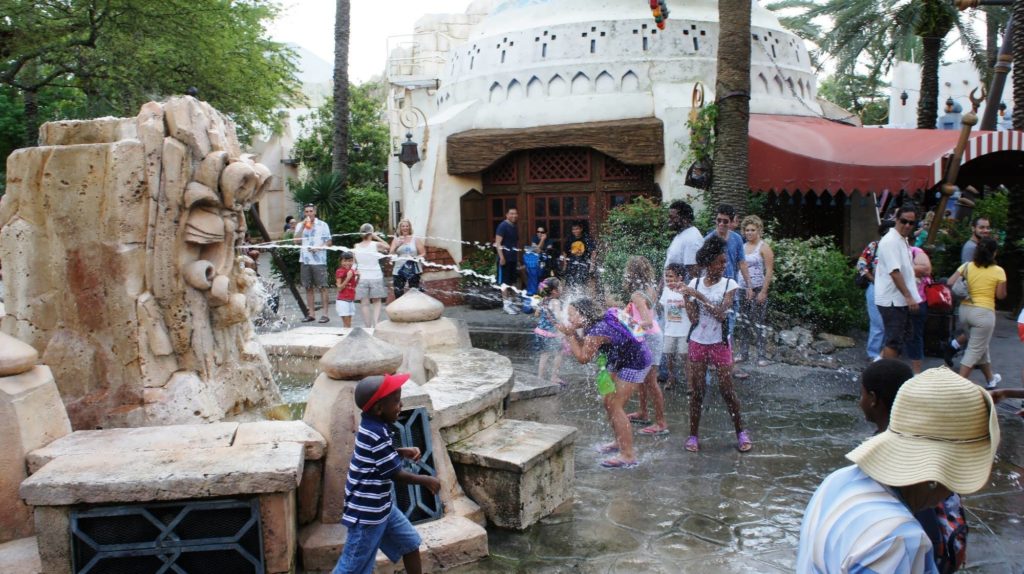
[623, 255, 669, 435]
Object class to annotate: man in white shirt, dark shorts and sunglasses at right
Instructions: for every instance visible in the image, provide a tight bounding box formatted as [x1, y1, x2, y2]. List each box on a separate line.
[874, 203, 921, 359]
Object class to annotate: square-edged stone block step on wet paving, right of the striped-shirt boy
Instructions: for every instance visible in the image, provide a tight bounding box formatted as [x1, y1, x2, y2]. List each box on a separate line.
[447, 418, 578, 529]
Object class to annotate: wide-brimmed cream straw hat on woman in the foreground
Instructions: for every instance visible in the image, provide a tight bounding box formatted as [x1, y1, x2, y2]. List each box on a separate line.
[846, 366, 999, 494]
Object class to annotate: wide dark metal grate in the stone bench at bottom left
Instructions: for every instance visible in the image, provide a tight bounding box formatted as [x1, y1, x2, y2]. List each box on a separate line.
[71, 498, 264, 574]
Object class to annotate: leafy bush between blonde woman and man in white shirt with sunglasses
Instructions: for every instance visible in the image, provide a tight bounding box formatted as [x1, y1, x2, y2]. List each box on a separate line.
[769, 237, 867, 333]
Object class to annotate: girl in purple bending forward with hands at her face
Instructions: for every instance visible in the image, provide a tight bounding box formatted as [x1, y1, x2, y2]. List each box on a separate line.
[558, 297, 650, 469]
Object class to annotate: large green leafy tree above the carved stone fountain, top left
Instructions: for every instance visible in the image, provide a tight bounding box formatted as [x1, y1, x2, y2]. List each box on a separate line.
[0, 0, 300, 144]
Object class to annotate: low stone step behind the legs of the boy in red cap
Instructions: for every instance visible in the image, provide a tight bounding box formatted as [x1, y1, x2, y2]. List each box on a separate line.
[299, 515, 487, 574]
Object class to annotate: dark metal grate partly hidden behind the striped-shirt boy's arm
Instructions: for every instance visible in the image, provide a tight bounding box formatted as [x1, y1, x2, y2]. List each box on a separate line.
[392, 407, 444, 524]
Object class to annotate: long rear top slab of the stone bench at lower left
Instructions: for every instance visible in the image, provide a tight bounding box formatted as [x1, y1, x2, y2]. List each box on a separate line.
[28, 423, 237, 474]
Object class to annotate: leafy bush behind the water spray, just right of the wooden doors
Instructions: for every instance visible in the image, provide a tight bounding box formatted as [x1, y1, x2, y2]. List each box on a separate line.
[598, 197, 672, 298]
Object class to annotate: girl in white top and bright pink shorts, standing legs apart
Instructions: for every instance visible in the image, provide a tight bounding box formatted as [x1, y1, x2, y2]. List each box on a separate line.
[679, 235, 752, 452]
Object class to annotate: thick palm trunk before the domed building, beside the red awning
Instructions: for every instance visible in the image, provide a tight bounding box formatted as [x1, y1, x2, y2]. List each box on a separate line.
[712, 0, 753, 214]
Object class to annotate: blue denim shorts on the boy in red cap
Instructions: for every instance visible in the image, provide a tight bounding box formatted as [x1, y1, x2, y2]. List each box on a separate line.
[332, 504, 421, 574]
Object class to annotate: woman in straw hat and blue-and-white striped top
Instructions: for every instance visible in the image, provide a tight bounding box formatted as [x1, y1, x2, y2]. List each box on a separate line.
[797, 368, 999, 573]
